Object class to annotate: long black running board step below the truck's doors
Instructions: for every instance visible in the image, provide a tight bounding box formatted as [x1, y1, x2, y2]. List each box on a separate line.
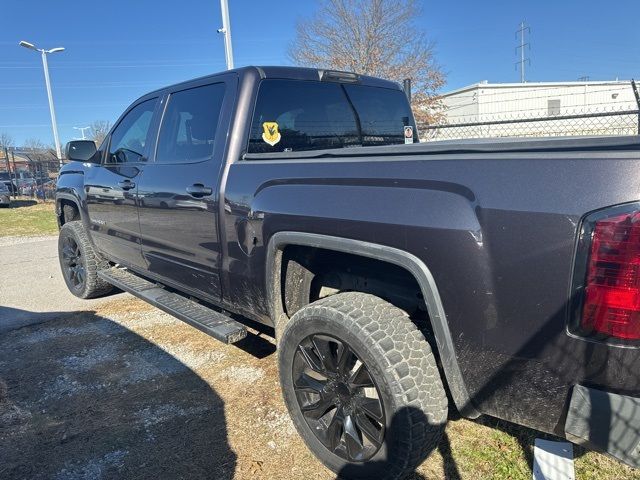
[98, 267, 247, 343]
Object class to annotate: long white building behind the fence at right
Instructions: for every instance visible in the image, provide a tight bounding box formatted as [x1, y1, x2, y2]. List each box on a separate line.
[425, 81, 638, 139]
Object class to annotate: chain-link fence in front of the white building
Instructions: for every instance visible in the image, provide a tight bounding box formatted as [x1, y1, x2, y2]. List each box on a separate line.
[419, 106, 640, 141]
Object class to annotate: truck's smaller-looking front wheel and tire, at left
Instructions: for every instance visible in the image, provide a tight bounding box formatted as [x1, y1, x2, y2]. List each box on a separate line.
[58, 221, 114, 298]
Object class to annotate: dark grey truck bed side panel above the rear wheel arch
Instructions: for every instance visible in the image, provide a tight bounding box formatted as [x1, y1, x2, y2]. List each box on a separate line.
[223, 151, 640, 433]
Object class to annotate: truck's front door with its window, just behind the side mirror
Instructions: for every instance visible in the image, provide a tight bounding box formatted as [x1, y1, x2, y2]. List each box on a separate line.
[85, 98, 158, 268]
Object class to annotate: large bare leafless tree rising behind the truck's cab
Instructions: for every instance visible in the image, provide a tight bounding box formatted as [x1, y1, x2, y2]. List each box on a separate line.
[289, 0, 445, 122]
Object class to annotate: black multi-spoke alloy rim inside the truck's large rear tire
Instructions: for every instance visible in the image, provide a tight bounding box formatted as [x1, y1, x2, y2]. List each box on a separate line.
[293, 334, 386, 462]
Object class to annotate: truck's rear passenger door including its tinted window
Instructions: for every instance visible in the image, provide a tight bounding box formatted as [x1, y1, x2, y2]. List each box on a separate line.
[138, 77, 231, 300]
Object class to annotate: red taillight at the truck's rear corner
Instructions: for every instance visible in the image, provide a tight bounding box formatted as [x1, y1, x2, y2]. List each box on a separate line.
[580, 212, 640, 340]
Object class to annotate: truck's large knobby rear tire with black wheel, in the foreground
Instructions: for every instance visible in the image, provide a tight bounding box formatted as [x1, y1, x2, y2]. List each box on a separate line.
[278, 292, 447, 479]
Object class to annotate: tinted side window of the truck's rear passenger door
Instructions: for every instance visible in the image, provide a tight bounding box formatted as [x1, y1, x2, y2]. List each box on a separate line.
[156, 83, 225, 163]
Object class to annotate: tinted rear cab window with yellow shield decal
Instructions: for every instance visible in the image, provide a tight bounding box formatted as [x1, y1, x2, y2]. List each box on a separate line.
[248, 79, 417, 153]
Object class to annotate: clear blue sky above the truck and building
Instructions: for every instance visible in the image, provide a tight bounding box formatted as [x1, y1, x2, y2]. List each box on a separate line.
[0, 0, 640, 145]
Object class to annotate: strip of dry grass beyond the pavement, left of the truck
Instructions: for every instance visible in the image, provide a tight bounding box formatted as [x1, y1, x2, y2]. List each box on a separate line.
[0, 199, 58, 237]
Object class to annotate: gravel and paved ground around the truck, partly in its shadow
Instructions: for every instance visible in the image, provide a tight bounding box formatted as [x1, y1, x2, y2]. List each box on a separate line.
[0, 234, 640, 480]
